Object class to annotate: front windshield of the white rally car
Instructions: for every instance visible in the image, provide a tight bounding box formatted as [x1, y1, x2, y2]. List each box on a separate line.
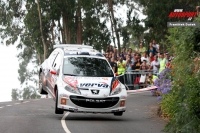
[63, 57, 114, 77]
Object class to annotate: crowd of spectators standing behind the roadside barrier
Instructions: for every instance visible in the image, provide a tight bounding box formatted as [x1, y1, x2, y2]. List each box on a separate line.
[104, 40, 174, 89]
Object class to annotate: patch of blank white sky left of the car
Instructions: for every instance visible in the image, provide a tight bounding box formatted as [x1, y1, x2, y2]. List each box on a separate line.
[0, 44, 20, 102]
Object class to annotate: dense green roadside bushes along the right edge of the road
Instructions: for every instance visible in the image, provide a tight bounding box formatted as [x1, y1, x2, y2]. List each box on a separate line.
[161, 17, 200, 133]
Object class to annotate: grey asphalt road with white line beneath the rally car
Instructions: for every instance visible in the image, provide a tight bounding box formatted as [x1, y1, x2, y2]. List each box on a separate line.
[0, 92, 166, 133]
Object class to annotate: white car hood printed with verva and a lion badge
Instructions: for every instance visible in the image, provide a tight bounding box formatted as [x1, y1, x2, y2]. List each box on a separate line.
[63, 76, 119, 98]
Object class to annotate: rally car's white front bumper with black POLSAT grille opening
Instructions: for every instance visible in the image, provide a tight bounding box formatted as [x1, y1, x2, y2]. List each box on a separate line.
[57, 94, 126, 113]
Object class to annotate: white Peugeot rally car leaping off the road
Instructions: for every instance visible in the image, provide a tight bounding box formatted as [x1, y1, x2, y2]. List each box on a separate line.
[39, 44, 127, 116]
